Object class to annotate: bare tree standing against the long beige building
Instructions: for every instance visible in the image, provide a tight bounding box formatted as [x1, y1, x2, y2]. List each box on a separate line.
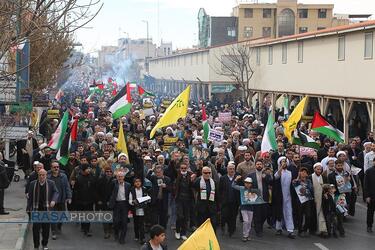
[214, 43, 254, 107]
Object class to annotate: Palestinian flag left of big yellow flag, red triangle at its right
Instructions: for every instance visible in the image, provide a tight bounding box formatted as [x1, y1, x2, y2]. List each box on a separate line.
[108, 84, 132, 119]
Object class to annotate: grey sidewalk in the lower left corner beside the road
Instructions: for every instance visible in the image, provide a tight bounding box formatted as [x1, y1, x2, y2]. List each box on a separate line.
[0, 170, 28, 250]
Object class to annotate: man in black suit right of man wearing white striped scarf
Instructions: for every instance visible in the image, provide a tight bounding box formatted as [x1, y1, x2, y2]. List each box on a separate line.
[219, 162, 240, 237]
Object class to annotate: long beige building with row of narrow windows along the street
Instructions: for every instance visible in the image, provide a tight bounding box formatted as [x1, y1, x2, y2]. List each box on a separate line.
[149, 21, 375, 141]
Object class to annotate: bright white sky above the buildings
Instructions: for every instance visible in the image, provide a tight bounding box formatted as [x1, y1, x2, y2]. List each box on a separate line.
[75, 0, 375, 53]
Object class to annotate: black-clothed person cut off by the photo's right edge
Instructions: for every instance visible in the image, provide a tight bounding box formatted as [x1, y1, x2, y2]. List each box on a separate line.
[364, 158, 375, 233]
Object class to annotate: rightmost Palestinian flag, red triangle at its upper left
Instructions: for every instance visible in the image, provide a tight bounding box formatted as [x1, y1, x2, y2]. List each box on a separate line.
[311, 112, 345, 142]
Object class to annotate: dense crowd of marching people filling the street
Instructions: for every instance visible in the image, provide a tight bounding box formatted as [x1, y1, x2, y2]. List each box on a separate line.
[1, 84, 375, 249]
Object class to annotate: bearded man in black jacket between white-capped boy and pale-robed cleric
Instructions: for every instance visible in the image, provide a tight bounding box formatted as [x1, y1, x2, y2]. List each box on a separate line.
[248, 160, 272, 237]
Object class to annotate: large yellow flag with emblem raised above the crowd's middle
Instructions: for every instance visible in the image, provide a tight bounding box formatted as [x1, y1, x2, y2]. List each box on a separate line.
[150, 85, 190, 138]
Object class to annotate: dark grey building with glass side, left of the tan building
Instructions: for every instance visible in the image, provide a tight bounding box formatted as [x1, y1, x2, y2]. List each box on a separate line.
[198, 8, 237, 48]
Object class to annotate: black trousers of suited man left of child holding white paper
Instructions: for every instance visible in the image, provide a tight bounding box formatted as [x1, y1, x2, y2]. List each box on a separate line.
[113, 201, 129, 241]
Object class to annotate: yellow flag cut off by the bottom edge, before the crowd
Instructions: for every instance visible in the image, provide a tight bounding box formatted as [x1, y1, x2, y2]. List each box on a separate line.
[178, 219, 220, 250]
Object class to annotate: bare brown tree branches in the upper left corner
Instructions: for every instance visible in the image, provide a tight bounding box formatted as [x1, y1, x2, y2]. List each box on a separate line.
[0, 0, 102, 81]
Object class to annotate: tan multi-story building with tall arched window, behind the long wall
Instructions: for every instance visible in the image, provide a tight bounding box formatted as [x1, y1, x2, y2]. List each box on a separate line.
[233, 0, 349, 41]
